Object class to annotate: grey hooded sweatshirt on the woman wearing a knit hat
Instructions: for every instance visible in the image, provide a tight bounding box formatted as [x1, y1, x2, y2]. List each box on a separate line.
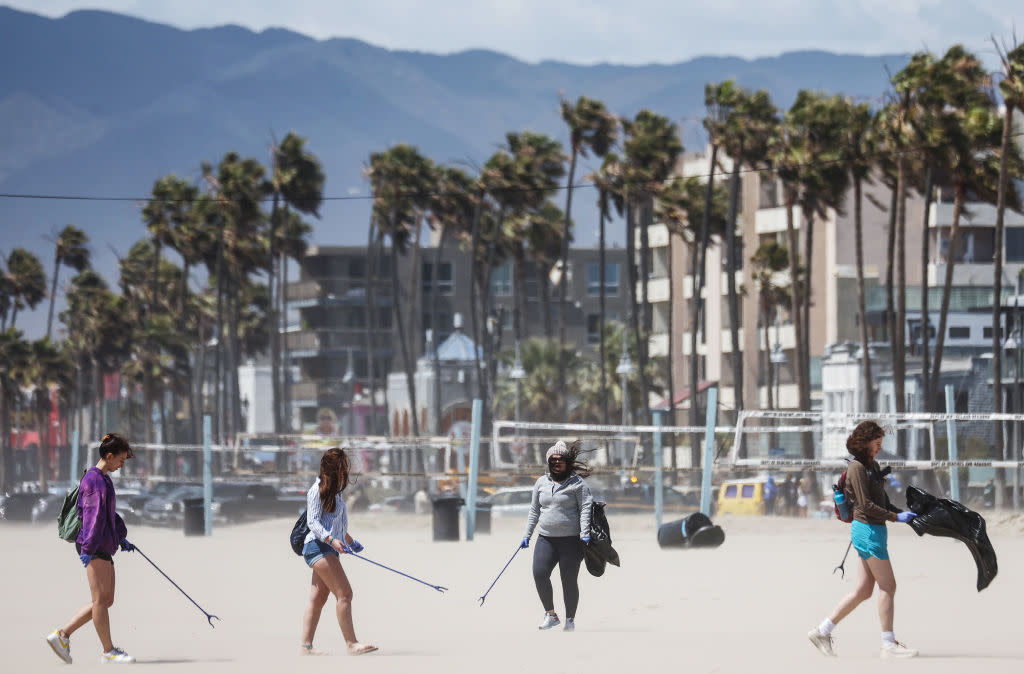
[525, 473, 594, 539]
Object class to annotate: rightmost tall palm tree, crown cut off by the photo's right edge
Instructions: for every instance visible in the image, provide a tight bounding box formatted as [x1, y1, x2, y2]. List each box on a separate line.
[992, 40, 1024, 482]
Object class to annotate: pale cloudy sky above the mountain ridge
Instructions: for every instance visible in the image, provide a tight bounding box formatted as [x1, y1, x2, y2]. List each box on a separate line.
[7, 0, 1024, 65]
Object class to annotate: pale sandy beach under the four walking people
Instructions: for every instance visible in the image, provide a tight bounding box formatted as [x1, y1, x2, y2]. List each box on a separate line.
[0, 506, 1024, 674]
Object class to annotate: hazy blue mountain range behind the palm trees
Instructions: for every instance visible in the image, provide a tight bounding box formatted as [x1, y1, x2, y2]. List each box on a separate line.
[0, 7, 907, 333]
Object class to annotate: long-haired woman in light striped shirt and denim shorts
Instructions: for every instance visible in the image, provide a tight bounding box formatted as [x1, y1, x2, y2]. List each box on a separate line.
[299, 447, 377, 656]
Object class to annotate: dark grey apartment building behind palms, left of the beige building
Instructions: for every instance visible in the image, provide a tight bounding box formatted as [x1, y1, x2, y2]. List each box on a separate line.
[286, 245, 627, 434]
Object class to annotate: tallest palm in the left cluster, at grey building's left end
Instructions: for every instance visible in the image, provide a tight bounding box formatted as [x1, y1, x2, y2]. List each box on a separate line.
[267, 132, 326, 433]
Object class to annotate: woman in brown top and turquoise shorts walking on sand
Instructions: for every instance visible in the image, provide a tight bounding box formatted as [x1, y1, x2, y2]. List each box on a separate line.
[807, 421, 918, 659]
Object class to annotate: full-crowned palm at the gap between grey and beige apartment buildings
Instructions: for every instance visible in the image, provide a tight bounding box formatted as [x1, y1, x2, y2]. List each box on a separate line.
[623, 110, 683, 422]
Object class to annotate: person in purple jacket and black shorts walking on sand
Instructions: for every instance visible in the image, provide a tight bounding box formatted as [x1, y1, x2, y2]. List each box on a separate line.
[46, 433, 135, 665]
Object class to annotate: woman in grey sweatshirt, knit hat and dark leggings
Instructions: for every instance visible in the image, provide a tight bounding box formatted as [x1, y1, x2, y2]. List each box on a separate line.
[519, 440, 594, 632]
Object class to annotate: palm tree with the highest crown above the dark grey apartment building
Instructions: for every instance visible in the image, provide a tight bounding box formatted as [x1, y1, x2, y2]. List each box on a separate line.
[558, 96, 618, 409]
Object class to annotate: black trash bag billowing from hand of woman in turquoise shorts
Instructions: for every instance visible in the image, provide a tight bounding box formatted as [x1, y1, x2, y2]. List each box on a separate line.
[906, 487, 998, 592]
